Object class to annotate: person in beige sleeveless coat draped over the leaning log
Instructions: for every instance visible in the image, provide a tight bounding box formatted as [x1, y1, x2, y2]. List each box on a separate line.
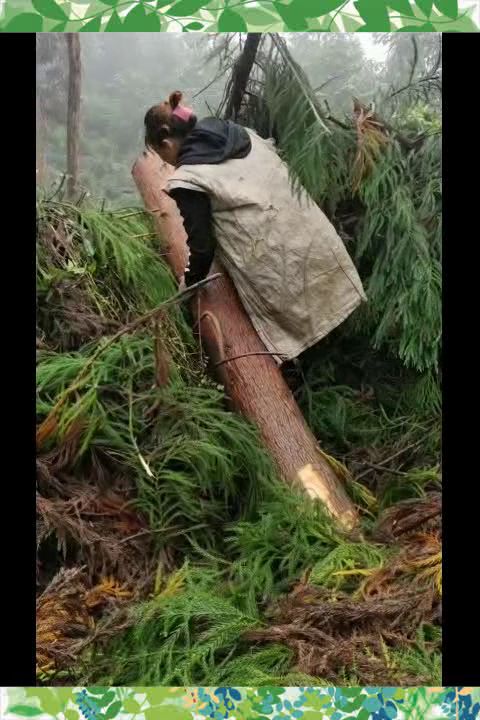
[144, 91, 366, 364]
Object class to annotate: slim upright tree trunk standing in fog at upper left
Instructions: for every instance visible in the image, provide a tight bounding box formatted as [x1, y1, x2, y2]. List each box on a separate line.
[67, 33, 82, 198]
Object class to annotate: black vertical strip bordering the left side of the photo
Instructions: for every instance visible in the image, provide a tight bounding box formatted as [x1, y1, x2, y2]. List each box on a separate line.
[0, 33, 36, 687]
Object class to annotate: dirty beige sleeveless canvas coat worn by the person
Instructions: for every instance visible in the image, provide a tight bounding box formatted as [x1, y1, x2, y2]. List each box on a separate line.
[167, 130, 366, 362]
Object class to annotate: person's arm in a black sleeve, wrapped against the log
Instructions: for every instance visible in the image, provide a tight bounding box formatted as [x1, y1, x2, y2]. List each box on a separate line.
[170, 188, 216, 287]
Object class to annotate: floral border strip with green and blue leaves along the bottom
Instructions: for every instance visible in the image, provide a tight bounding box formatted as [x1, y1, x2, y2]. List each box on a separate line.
[0, 687, 480, 720]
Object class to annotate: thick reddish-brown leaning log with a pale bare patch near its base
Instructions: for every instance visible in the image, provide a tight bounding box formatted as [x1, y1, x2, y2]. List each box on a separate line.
[132, 151, 357, 529]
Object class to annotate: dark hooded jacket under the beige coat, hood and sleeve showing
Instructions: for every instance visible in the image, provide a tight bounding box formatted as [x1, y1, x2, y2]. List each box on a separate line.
[171, 118, 251, 286]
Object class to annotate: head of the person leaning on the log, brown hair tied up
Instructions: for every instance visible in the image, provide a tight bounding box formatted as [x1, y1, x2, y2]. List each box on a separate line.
[144, 90, 197, 165]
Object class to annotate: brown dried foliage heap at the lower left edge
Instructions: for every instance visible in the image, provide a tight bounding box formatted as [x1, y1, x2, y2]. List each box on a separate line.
[37, 424, 154, 680]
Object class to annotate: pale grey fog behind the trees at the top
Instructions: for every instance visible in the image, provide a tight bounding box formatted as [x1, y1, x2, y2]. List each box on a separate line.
[37, 33, 439, 206]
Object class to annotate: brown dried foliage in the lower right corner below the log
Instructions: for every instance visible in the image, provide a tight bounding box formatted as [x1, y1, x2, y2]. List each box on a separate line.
[247, 493, 441, 685]
